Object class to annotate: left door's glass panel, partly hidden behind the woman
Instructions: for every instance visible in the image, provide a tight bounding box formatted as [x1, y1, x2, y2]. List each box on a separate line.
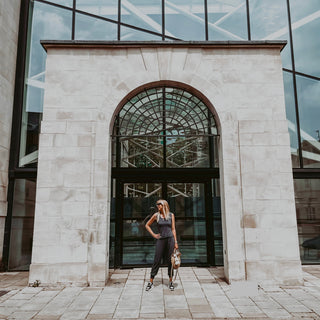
[122, 183, 162, 265]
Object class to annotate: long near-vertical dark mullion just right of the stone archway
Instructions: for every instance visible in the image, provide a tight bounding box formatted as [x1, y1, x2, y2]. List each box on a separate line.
[287, 0, 303, 168]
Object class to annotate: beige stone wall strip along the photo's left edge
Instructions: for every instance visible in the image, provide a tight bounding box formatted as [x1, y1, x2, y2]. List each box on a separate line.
[0, 0, 20, 262]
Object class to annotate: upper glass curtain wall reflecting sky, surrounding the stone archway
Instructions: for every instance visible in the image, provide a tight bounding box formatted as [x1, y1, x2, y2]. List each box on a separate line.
[8, 0, 320, 268]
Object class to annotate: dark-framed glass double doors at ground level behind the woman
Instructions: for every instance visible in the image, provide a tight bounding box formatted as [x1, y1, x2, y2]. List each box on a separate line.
[110, 180, 222, 267]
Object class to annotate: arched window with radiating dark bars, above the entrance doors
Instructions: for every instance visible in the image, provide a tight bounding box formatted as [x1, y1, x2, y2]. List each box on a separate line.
[113, 86, 218, 168]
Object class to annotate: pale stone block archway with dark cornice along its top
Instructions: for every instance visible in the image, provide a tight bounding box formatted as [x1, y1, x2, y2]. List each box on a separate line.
[29, 42, 302, 285]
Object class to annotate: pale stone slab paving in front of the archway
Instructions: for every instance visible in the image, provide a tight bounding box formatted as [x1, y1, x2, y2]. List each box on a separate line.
[0, 266, 320, 320]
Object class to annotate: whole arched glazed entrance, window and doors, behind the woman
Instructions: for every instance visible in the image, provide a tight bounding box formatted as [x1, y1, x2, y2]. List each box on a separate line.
[109, 86, 223, 268]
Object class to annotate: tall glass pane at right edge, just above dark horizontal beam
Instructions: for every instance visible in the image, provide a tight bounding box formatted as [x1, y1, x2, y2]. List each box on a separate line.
[296, 76, 320, 168]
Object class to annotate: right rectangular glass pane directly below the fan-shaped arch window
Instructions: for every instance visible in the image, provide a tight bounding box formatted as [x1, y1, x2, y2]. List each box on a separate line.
[166, 137, 209, 168]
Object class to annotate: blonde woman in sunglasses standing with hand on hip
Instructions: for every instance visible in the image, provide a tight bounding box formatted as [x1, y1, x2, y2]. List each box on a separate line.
[146, 200, 178, 291]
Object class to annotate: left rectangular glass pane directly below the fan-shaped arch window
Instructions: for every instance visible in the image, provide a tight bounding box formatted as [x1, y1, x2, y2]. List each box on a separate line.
[120, 137, 163, 168]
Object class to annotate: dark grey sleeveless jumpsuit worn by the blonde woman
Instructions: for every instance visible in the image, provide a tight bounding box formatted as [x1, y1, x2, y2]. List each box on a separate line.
[150, 212, 174, 279]
